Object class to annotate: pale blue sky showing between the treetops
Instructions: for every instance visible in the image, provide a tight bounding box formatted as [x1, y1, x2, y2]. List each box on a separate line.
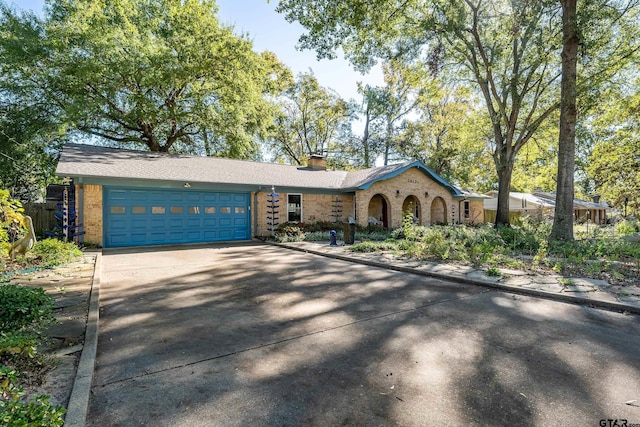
[16, 0, 382, 100]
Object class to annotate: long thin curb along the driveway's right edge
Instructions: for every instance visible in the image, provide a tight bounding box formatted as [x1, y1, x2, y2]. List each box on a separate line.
[278, 242, 640, 314]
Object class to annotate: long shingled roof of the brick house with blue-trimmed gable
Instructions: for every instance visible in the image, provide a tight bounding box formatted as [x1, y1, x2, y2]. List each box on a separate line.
[56, 144, 462, 195]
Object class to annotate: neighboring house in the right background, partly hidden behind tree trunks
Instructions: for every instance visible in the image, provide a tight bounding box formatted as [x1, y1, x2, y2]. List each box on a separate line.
[484, 191, 609, 224]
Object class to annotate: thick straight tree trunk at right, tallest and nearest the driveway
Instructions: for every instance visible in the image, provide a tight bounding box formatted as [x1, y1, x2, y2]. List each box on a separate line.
[549, 0, 579, 241]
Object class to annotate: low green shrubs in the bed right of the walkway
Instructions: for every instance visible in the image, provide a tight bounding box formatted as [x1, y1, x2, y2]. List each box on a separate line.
[350, 218, 640, 284]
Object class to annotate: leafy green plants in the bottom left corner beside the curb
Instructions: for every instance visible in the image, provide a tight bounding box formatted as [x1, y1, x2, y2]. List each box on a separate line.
[0, 365, 66, 427]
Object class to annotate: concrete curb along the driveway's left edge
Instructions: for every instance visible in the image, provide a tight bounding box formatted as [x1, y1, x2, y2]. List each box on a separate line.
[64, 252, 102, 427]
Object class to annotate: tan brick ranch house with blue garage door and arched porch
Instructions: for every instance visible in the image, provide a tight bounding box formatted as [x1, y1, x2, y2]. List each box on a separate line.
[56, 144, 483, 247]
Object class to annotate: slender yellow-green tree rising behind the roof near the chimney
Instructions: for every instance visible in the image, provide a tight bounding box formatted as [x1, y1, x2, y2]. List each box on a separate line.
[268, 72, 350, 165]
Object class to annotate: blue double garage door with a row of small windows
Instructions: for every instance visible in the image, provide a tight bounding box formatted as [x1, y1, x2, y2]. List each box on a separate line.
[104, 187, 251, 247]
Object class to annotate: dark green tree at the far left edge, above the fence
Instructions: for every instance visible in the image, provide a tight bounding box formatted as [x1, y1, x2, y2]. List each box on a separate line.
[0, 3, 65, 201]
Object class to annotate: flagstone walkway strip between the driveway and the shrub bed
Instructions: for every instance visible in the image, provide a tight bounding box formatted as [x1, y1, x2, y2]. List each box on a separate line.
[277, 242, 640, 314]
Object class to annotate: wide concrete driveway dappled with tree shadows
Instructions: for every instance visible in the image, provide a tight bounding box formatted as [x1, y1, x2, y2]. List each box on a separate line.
[87, 244, 640, 426]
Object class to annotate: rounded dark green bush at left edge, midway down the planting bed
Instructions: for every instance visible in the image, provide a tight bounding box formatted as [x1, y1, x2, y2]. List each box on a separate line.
[0, 284, 54, 333]
